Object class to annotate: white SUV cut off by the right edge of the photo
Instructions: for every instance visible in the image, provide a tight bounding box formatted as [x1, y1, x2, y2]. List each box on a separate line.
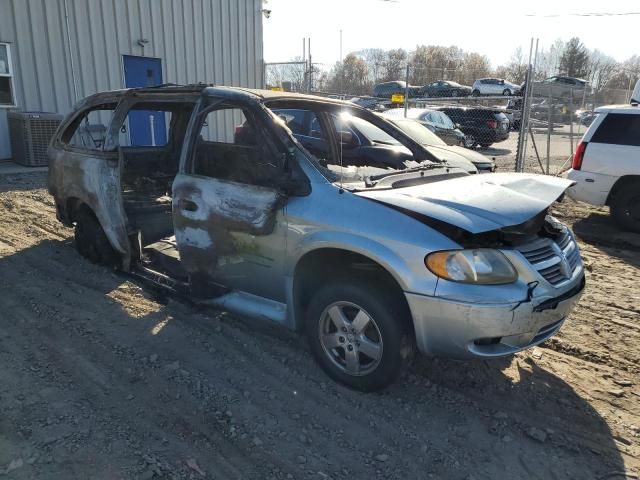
[565, 86, 640, 232]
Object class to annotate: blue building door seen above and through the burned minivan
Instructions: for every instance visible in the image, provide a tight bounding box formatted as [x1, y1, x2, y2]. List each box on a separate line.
[123, 55, 167, 146]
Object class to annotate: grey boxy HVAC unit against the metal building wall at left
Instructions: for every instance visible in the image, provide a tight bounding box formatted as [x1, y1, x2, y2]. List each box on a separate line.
[8, 112, 63, 167]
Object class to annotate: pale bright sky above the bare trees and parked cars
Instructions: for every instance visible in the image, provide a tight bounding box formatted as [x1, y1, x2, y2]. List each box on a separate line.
[263, 0, 640, 68]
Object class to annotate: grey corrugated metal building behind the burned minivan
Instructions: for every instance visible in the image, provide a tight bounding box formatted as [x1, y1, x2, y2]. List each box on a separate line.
[0, 0, 263, 159]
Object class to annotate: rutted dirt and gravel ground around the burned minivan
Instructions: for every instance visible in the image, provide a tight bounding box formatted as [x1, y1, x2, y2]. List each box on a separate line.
[0, 173, 640, 480]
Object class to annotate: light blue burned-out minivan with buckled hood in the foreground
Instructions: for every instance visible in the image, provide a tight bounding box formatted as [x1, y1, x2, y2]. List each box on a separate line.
[49, 85, 584, 390]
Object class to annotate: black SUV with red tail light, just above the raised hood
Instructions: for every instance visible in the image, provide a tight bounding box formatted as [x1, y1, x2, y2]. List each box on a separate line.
[436, 106, 509, 148]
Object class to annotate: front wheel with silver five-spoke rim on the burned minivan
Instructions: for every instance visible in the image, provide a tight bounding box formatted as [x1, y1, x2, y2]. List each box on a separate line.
[305, 279, 414, 391]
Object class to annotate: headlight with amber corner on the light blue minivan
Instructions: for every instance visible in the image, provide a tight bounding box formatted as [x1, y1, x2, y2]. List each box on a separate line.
[424, 248, 518, 285]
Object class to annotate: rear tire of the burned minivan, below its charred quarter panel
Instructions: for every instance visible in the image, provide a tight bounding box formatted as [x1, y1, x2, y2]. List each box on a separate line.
[74, 206, 119, 267]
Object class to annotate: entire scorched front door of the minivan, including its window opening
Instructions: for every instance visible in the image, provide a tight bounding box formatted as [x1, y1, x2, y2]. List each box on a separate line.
[172, 100, 286, 302]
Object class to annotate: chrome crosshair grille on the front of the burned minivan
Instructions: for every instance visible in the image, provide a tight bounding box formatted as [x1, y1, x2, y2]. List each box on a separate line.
[517, 227, 581, 286]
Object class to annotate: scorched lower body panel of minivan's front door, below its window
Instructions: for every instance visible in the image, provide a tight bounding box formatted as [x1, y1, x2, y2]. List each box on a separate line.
[173, 174, 285, 299]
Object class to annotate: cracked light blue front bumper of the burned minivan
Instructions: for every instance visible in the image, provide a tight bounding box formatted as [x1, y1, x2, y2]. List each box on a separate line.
[405, 277, 584, 358]
